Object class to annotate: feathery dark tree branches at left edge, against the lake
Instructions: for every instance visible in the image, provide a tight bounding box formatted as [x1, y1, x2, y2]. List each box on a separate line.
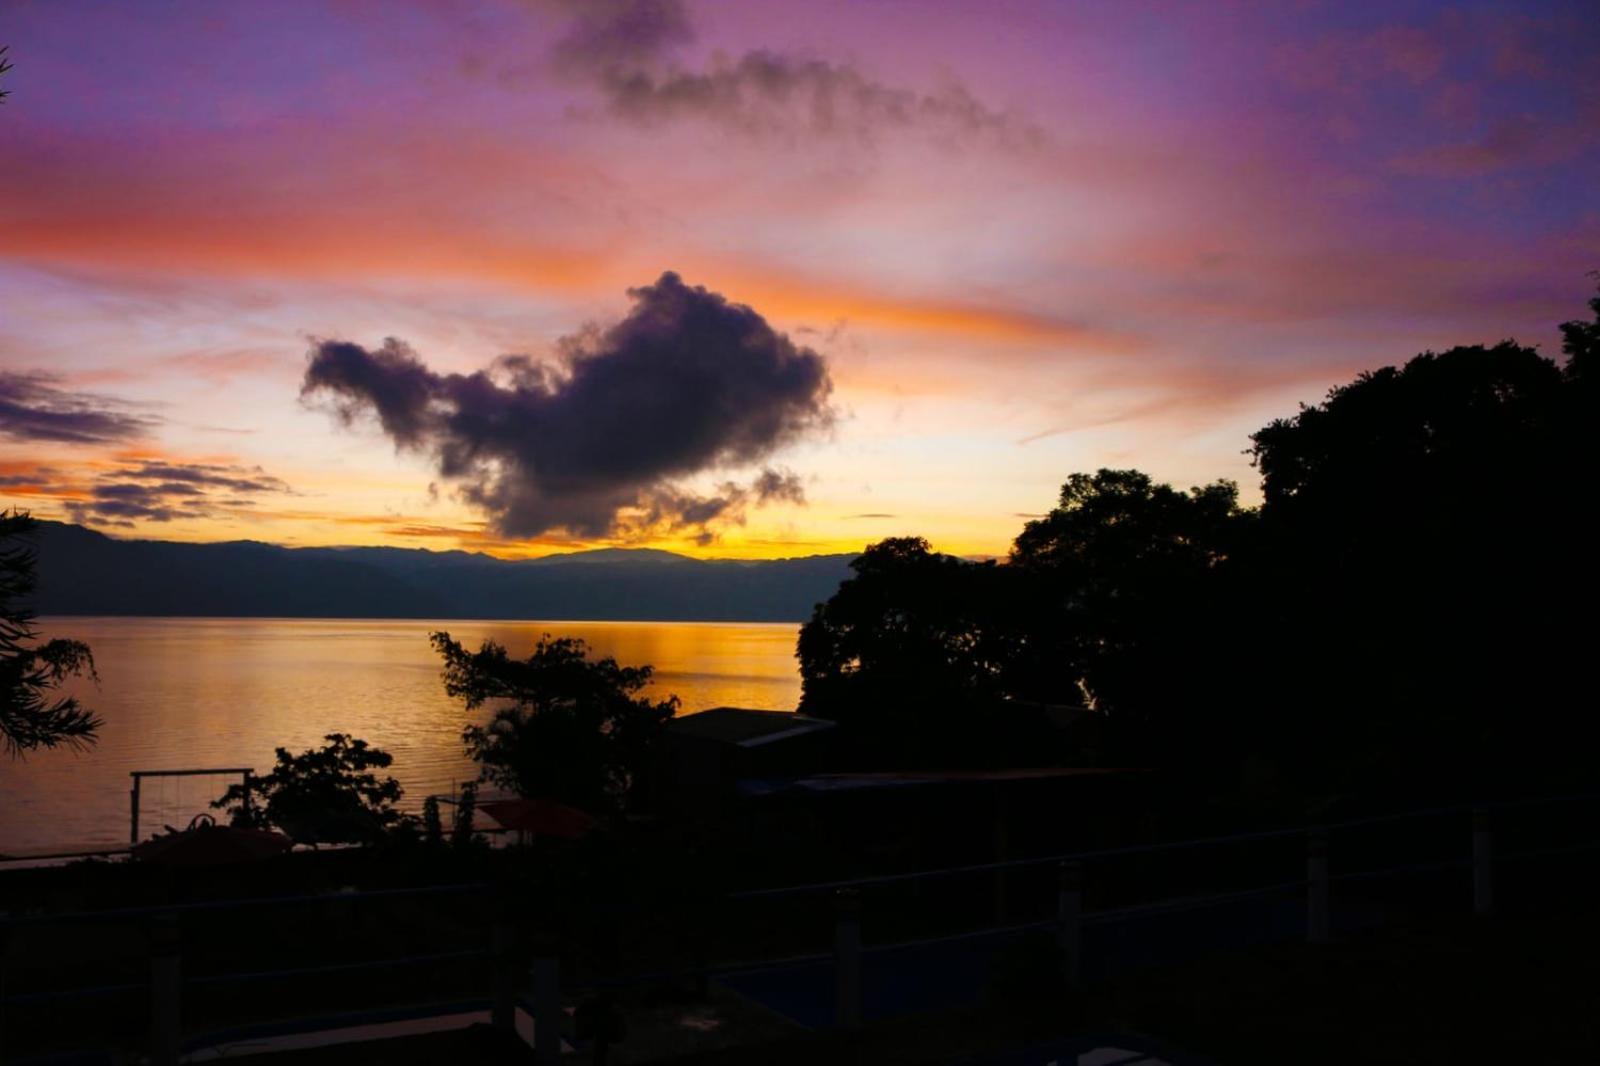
[0, 511, 101, 757]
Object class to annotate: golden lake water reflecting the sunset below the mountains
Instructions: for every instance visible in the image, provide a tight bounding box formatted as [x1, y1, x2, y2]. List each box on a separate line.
[0, 618, 800, 855]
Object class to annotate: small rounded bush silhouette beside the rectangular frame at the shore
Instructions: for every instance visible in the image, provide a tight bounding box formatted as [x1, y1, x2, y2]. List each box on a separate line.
[211, 733, 406, 844]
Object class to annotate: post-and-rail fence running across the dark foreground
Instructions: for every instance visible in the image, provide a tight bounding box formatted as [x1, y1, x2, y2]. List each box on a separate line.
[0, 784, 1600, 1066]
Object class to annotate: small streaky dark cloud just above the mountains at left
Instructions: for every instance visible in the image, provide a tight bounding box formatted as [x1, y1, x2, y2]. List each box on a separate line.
[64, 459, 291, 525]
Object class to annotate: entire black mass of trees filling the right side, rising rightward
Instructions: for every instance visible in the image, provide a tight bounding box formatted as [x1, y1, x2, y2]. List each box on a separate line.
[798, 286, 1600, 795]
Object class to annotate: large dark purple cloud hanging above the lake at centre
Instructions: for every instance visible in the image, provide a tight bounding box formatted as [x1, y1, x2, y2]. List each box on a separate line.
[301, 274, 832, 536]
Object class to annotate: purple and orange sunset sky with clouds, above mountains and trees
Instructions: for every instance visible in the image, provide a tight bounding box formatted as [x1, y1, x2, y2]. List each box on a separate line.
[0, 0, 1600, 557]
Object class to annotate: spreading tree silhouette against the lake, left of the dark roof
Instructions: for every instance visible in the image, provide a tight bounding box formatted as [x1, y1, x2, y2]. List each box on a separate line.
[430, 632, 678, 810]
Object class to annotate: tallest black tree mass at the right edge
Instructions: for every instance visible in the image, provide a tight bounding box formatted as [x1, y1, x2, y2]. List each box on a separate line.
[1253, 307, 1600, 791]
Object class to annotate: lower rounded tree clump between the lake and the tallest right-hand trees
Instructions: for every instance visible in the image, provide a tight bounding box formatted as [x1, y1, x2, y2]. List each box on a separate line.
[798, 471, 1246, 765]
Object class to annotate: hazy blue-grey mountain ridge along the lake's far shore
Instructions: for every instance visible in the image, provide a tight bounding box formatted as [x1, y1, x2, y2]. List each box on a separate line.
[35, 522, 853, 621]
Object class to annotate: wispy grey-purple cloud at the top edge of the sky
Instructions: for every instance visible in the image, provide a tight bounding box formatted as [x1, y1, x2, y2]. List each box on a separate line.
[555, 0, 1043, 149]
